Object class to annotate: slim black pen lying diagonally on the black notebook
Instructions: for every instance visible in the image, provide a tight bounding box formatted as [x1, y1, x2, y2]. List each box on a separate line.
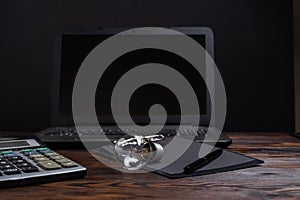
[184, 149, 223, 174]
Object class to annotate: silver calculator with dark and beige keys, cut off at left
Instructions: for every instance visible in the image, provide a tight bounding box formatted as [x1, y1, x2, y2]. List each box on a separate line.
[0, 139, 86, 188]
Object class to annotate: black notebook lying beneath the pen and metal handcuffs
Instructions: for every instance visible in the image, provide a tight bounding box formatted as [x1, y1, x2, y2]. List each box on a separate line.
[95, 138, 263, 178]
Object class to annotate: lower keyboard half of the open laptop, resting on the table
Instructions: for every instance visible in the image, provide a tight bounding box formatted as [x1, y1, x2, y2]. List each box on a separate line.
[36, 126, 232, 148]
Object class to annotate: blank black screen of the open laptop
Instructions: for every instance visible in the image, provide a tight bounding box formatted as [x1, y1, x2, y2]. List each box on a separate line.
[59, 34, 208, 124]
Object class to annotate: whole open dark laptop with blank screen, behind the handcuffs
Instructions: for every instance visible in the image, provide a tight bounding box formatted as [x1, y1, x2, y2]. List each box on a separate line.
[36, 27, 232, 148]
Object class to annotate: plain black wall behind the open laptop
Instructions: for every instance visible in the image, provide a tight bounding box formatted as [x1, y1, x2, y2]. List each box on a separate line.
[0, 0, 294, 131]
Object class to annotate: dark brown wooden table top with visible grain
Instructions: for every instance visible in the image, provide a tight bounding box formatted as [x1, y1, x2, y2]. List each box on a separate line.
[0, 133, 300, 200]
